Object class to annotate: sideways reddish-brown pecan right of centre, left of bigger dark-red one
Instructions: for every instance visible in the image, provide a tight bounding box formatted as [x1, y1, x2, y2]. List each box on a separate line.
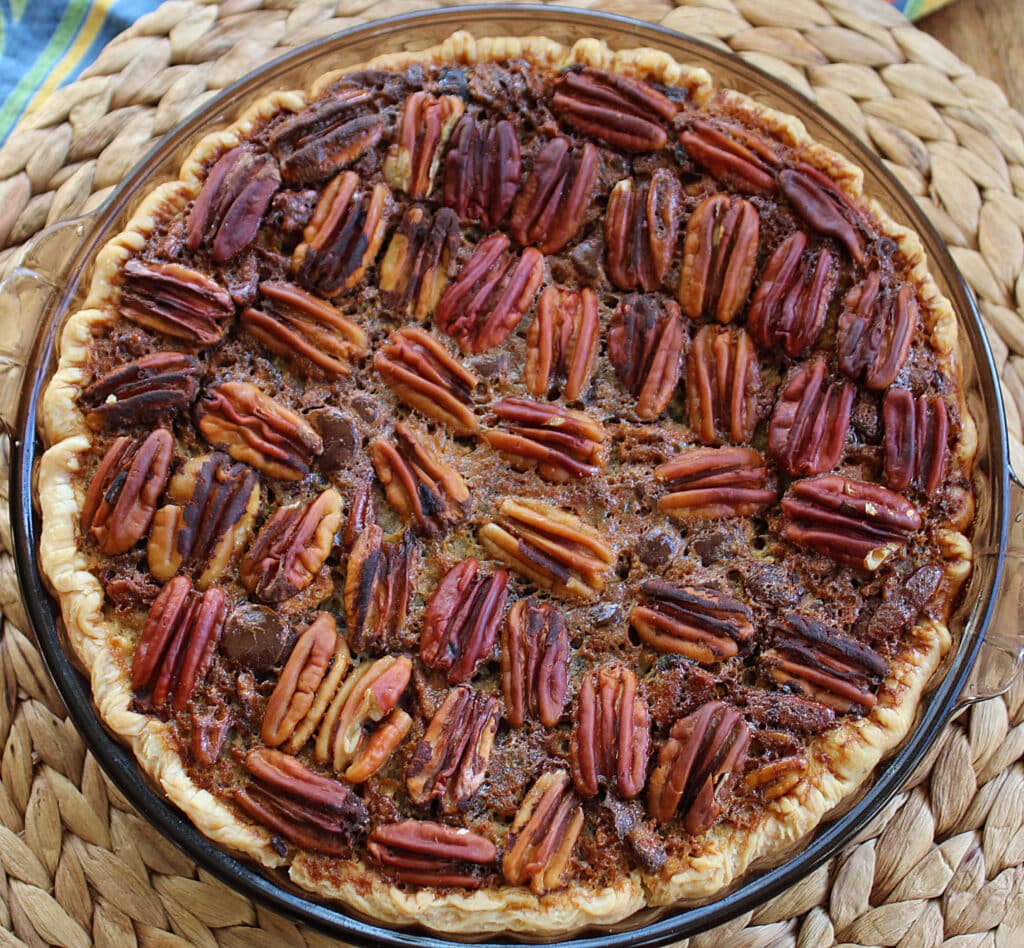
[654, 447, 779, 520]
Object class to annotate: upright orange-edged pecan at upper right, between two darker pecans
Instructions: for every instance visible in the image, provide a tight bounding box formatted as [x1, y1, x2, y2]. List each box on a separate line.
[679, 195, 761, 322]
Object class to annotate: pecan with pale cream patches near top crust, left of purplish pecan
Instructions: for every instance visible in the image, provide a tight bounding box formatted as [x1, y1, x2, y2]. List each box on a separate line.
[384, 91, 466, 201]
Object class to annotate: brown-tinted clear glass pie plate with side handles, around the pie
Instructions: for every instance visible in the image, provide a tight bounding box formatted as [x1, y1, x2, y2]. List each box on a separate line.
[0, 6, 1024, 948]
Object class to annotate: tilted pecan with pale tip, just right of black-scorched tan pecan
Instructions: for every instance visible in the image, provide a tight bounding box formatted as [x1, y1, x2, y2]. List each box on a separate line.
[239, 490, 341, 602]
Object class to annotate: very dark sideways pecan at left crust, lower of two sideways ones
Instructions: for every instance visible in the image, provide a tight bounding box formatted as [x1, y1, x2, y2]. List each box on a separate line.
[78, 352, 202, 429]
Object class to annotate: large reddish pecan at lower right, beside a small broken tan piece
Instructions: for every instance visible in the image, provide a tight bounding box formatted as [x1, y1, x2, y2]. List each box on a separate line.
[647, 701, 751, 835]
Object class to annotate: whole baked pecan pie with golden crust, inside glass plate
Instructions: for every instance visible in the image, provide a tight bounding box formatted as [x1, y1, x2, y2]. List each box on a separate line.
[39, 33, 975, 934]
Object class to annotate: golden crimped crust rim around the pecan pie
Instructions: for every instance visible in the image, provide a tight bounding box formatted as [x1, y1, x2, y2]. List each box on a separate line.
[39, 33, 976, 936]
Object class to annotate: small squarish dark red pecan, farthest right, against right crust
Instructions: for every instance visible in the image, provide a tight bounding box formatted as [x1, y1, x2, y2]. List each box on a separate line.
[882, 388, 949, 493]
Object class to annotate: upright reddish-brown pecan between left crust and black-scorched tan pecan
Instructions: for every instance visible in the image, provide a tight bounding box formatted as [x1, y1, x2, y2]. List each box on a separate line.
[82, 428, 174, 556]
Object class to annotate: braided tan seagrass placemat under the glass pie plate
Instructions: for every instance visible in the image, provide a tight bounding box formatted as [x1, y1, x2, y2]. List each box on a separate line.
[0, 0, 1024, 948]
